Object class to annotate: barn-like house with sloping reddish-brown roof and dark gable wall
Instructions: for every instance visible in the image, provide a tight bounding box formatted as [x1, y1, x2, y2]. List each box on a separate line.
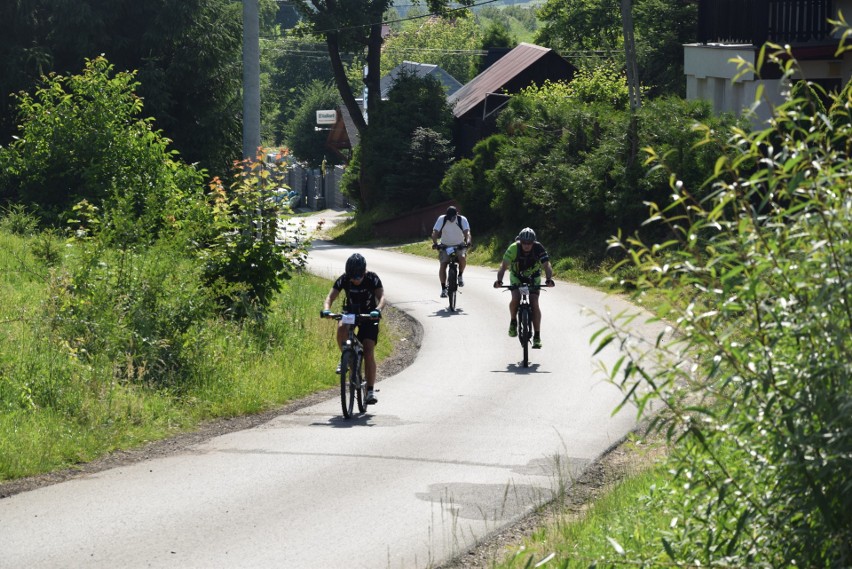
[447, 43, 576, 156]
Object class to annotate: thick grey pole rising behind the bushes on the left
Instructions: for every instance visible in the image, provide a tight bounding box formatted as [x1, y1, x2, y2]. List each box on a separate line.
[243, 0, 260, 159]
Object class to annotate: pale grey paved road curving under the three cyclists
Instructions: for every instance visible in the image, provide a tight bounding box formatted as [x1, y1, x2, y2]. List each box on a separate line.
[0, 211, 658, 569]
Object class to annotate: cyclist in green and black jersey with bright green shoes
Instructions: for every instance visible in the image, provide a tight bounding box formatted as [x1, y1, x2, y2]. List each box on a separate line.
[494, 227, 556, 349]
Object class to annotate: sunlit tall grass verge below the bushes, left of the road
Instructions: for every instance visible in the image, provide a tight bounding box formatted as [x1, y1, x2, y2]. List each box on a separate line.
[0, 226, 397, 480]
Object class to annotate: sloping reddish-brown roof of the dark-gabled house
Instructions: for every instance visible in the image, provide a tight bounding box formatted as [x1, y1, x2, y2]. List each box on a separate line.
[447, 43, 553, 118]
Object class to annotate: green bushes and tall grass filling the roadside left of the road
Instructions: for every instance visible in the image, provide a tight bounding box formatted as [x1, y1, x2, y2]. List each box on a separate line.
[0, 58, 393, 480]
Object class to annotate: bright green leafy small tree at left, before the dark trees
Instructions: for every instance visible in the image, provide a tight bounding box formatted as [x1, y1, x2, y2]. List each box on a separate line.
[0, 57, 202, 239]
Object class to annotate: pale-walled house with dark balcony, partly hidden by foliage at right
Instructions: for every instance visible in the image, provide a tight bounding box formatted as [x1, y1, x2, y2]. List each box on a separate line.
[684, 0, 852, 124]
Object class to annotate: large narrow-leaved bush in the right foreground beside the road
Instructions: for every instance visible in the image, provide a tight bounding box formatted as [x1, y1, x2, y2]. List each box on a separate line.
[597, 45, 852, 567]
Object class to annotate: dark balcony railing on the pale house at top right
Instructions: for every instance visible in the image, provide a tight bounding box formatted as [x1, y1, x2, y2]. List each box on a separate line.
[698, 0, 837, 45]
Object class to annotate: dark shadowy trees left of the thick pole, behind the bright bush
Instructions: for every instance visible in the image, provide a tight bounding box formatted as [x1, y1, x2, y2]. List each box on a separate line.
[0, 0, 256, 176]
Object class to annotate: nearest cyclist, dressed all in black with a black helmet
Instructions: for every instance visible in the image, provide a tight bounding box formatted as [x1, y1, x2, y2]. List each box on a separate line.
[321, 253, 385, 405]
